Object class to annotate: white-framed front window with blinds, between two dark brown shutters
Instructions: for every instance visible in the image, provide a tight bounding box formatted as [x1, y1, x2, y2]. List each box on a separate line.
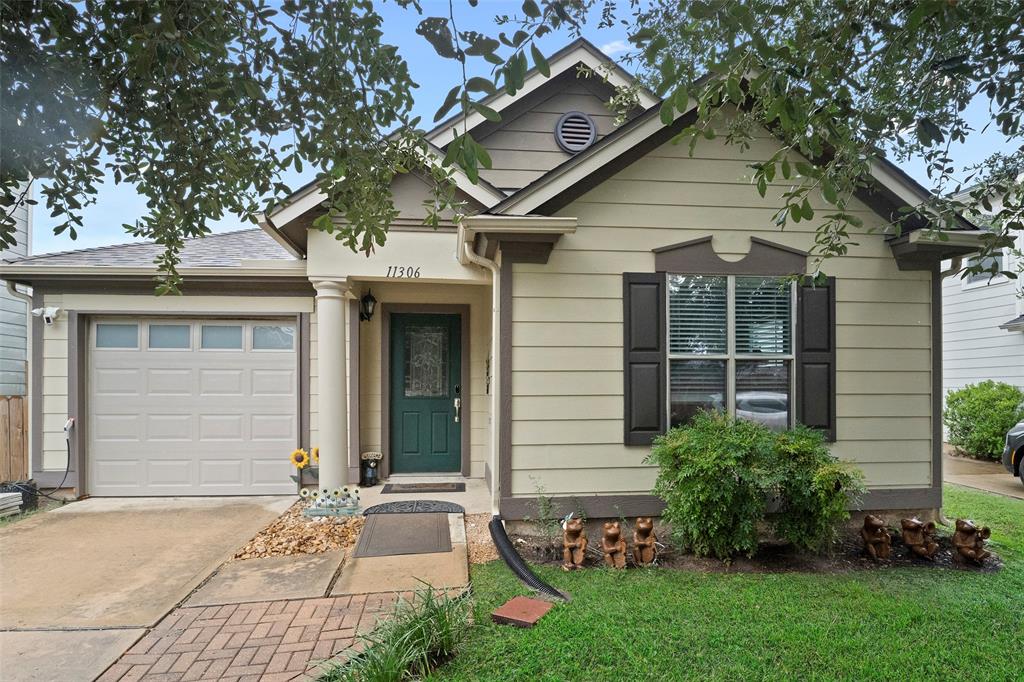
[668, 274, 794, 429]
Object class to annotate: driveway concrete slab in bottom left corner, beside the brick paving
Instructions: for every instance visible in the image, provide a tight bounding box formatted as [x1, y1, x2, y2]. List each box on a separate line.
[0, 630, 145, 682]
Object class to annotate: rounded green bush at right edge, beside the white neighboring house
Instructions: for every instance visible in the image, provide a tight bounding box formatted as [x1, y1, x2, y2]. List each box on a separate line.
[942, 381, 1024, 460]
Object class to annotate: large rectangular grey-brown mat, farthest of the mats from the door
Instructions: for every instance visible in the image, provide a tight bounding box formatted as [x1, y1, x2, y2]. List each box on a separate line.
[353, 513, 452, 557]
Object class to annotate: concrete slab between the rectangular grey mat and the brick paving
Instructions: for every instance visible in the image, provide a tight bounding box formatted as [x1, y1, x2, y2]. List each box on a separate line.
[331, 544, 469, 597]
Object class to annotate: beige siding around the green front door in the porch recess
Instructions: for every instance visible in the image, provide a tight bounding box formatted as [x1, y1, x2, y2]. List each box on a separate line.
[359, 282, 490, 478]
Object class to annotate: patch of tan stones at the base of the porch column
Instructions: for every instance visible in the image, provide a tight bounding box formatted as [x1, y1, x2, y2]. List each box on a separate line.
[232, 500, 365, 560]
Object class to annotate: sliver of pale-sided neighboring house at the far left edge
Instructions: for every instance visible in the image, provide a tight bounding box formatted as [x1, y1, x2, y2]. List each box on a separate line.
[0, 182, 32, 395]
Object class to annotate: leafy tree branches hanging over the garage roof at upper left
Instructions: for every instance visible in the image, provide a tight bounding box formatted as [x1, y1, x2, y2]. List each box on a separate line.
[0, 0, 452, 291]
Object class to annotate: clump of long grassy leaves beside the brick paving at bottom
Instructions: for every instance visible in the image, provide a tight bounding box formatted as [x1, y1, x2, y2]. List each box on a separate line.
[318, 585, 469, 682]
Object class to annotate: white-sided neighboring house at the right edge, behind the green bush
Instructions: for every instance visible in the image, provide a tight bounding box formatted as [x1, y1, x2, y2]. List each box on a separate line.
[942, 188, 1024, 392]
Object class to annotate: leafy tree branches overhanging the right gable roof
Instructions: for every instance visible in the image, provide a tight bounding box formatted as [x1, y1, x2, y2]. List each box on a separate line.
[427, 0, 1024, 276]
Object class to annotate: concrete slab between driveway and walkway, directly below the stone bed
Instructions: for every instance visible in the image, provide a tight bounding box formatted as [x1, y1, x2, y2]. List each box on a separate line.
[184, 550, 345, 606]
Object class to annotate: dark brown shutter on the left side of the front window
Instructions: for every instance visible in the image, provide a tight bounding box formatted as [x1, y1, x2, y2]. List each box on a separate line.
[623, 272, 668, 445]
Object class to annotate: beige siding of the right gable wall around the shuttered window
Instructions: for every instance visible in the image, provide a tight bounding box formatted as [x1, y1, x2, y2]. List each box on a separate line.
[512, 120, 933, 497]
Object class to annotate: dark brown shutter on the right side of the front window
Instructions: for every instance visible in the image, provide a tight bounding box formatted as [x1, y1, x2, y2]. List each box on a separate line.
[795, 278, 836, 441]
